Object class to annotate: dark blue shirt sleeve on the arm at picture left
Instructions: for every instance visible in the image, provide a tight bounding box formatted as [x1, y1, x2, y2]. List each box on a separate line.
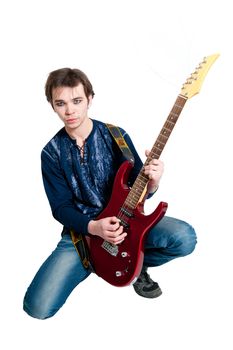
[41, 150, 91, 234]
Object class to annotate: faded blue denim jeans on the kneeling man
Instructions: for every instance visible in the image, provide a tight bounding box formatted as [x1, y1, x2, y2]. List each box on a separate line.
[24, 216, 196, 319]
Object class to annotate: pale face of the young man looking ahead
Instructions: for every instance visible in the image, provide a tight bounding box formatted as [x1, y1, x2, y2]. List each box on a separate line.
[52, 84, 92, 130]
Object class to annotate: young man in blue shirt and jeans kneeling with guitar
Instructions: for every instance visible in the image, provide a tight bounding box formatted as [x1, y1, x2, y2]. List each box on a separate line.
[24, 68, 196, 319]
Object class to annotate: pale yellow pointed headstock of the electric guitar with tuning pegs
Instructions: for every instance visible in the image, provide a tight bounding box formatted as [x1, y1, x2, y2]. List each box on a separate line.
[180, 54, 219, 98]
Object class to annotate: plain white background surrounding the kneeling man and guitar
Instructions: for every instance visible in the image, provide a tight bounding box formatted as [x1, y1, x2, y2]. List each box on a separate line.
[0, 0, 233, 350]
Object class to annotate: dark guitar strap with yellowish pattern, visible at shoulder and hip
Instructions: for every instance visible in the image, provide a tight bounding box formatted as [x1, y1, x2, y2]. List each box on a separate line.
[70, 124, 134, 270]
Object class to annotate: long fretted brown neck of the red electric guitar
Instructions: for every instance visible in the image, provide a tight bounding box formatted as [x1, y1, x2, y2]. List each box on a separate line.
[125, 95, 187, 210]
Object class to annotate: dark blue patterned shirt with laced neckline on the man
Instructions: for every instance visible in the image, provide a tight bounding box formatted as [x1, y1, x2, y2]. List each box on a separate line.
[41, 120, 142, 234]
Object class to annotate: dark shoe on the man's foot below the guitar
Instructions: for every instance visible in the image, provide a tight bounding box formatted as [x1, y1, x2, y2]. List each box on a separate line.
[133, 266, 162, 298]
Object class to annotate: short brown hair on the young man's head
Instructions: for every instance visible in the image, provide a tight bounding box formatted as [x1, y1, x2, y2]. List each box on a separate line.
[45, 68, 95, 104]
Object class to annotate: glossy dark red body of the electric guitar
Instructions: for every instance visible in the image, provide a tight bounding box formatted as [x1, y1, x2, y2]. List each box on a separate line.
[86, 161, 167, 287]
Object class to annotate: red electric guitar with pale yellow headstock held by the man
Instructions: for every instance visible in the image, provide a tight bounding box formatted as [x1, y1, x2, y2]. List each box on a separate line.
[86, 54, 219, 287]
